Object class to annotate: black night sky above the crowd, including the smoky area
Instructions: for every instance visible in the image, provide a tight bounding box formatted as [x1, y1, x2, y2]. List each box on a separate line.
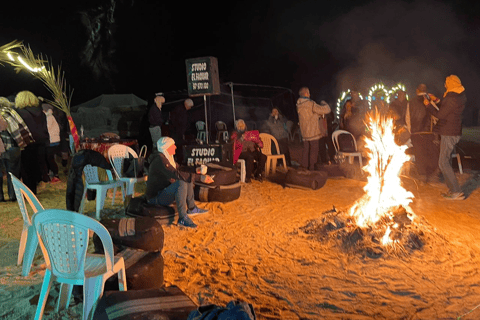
[0, 0, 480, 125]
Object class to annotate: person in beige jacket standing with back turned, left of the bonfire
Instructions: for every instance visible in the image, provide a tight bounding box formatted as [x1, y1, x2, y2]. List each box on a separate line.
[297, 87, 331, 170]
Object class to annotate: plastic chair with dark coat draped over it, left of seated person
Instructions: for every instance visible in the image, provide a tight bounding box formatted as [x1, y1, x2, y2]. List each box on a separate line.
[78, 164, 125, 220]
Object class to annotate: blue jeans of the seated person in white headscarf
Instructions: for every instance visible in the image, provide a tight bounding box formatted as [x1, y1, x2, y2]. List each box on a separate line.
[147, 180, 196, 219]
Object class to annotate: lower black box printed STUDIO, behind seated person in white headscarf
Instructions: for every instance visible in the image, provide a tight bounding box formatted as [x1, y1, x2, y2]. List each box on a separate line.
[183, 143, 233, 167]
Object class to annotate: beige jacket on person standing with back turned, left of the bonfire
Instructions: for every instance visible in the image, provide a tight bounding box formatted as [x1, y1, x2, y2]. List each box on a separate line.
[297, 97, 330, 141]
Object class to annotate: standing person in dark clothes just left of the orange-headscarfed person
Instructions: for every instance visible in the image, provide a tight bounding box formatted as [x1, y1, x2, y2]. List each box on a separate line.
[405, 83, 440, 183]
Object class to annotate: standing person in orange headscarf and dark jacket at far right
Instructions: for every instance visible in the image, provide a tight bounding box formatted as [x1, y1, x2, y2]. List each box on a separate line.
[423, 75, 467, 200]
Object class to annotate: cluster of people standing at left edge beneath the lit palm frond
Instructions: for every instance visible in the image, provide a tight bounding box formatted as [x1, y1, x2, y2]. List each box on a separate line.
[0, 91, 69, 201]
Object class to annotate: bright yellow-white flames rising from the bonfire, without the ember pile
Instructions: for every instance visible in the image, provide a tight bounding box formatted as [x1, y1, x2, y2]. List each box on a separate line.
[350, 111, 413, 239]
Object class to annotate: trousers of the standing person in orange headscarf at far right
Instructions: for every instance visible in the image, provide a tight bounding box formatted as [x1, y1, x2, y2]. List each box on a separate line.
[438, 136, 462, 193]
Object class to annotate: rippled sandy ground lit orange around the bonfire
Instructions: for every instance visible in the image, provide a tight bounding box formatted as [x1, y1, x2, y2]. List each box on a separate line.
[0, 128, 480, 319]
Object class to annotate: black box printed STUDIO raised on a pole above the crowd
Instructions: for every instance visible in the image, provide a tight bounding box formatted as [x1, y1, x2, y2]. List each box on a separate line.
[185, 57, 220, 97]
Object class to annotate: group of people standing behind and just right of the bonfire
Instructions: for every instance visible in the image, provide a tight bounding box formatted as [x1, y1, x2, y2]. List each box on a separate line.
[340, 75, 466, 200]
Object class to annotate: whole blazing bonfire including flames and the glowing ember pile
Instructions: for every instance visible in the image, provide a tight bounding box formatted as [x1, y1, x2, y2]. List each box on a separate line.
[301, 111, 429, 257]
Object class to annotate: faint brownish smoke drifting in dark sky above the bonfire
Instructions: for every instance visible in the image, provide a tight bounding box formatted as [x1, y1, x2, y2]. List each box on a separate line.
[318, 1, 479, 124]
